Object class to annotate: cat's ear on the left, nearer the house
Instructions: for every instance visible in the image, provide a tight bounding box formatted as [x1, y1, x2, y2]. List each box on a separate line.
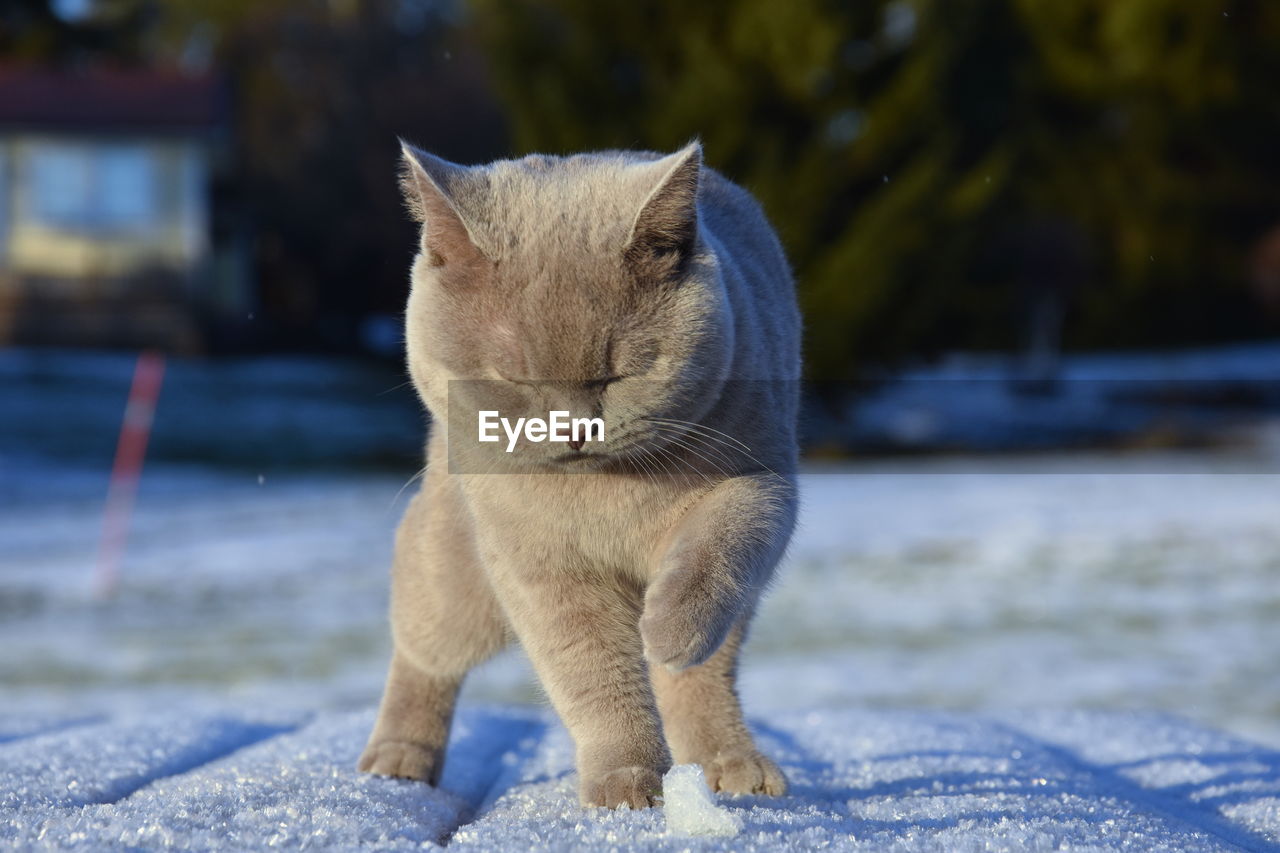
[401, 140, 480, 266]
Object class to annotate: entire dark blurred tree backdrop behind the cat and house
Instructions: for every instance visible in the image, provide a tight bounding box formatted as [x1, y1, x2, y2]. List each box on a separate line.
[10, 0, 1280, 361]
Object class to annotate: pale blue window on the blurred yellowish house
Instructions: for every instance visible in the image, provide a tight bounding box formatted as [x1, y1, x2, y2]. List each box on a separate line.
[28, 143, 157, 231]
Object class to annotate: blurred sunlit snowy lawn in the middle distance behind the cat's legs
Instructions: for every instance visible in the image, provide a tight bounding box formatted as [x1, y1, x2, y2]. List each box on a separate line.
[0, 457, 1280, 745]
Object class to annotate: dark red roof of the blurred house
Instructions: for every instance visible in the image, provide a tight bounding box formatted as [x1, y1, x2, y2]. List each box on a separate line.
[0, 67, 224, 132]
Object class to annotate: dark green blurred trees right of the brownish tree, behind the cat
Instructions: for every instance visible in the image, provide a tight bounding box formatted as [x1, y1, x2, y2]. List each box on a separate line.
[472, 0, 1280, 378]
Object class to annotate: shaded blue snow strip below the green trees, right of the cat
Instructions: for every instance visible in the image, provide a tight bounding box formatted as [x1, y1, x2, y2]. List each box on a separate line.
[829, 343, 1280, 450]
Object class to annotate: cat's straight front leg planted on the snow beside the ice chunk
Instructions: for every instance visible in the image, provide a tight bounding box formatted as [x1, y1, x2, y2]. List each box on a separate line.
[493, 555, 671, 808]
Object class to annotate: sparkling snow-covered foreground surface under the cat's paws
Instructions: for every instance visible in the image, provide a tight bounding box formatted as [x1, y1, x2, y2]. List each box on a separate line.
[0, 706, 1280, 852]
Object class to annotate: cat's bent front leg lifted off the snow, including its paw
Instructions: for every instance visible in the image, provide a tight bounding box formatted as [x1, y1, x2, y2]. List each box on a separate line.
[640, 474, 796, 671]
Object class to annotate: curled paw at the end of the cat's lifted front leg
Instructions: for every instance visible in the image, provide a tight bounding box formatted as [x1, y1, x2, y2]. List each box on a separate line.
[640, 570, 735, 670]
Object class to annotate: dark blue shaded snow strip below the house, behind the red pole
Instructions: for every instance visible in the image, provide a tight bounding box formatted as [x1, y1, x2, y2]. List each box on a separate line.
[0, 350, 422, 470]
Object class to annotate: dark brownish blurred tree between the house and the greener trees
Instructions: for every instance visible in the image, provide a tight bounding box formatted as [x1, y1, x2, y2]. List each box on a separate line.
[154, 0, 504, 347]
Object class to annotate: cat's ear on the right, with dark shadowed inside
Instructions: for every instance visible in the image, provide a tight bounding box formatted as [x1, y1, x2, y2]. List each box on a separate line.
[626, 142, 703, 274]
